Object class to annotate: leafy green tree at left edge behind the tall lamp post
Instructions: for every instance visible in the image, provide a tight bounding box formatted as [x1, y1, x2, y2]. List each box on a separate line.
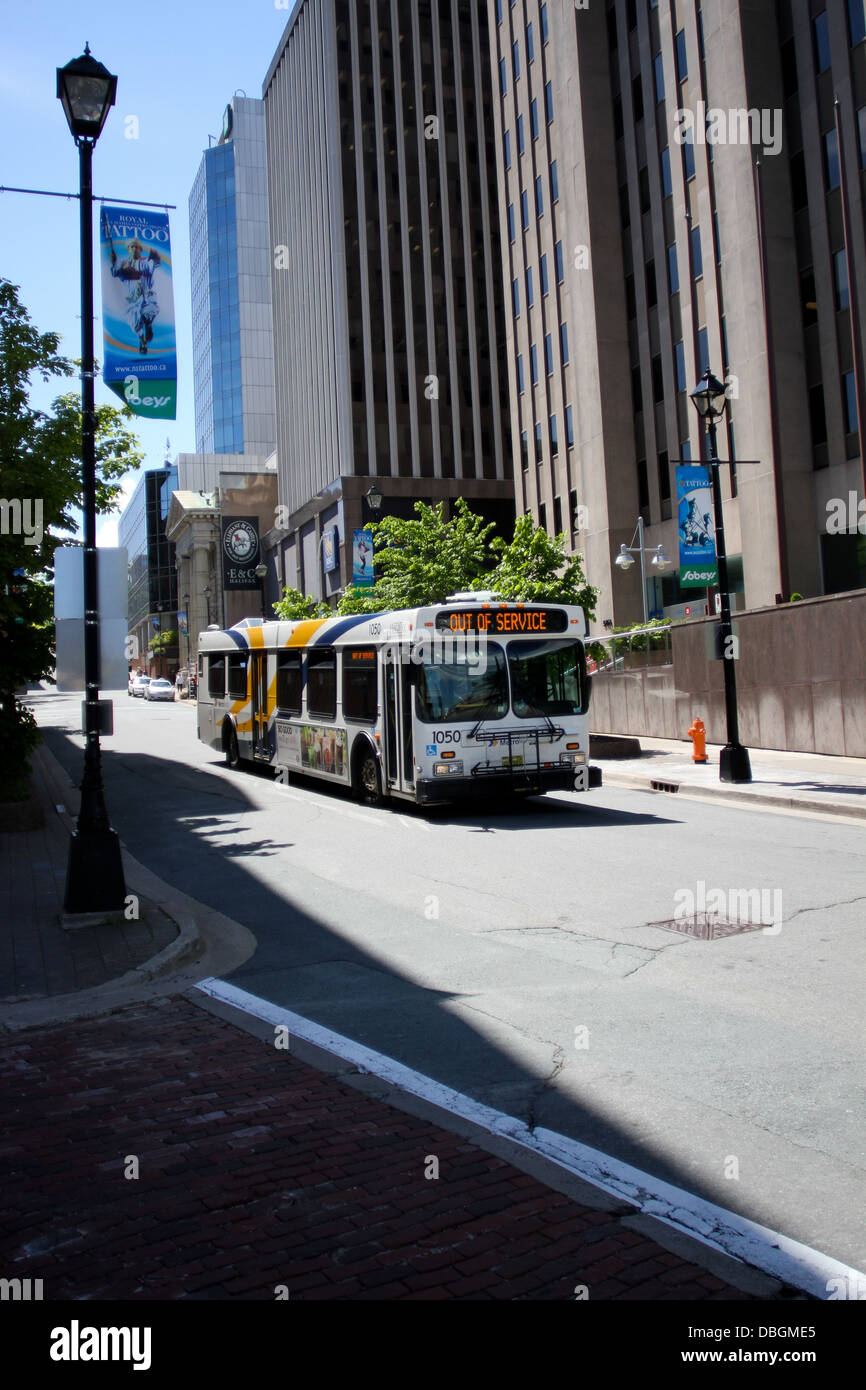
[0, 278, 143, 790]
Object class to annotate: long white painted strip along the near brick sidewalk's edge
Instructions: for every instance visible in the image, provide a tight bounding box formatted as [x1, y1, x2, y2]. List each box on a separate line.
[196, 977, 866, 1300]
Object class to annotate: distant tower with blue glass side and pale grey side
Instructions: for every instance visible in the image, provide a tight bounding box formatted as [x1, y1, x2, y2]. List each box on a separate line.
[189, 96, 275, 456]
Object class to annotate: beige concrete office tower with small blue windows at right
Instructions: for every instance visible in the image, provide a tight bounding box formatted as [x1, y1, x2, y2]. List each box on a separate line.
[489, 0, 866, 621]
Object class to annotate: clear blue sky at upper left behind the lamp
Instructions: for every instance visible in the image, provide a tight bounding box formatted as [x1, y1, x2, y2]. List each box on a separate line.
[0, 0, 289, 545]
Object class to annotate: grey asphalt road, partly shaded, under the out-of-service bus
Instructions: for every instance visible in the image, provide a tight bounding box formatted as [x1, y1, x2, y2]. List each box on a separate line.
[35, 692, 866, 1269]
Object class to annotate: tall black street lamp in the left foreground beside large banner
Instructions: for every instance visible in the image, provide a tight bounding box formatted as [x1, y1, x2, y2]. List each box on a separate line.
[57, 44, 126, 913]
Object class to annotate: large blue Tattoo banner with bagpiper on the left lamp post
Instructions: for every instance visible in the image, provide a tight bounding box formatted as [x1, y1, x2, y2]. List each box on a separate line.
[99, 207, 178, 420]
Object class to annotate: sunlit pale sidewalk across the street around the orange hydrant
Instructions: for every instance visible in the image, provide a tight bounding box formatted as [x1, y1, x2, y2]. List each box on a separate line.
[595, 735, 866, 819]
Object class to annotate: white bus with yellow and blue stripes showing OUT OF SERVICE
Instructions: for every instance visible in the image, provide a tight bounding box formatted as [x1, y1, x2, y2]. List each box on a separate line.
[197, 592, 602, 805]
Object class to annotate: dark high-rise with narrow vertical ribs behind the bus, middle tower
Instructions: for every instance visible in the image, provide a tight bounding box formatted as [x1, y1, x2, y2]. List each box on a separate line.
[263, 0, 513, 594]
